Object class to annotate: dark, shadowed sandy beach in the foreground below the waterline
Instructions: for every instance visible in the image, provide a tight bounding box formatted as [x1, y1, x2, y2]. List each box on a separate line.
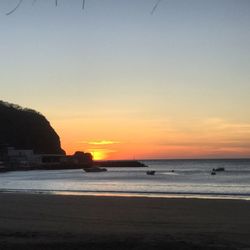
[0, 193, 250, 250]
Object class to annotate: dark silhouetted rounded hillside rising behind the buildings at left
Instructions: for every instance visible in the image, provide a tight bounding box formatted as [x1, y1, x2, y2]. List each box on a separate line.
[0, 101, 65, 154]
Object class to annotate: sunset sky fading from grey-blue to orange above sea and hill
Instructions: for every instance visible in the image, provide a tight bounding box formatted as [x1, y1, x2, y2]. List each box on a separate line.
[0, 0, 250, 159]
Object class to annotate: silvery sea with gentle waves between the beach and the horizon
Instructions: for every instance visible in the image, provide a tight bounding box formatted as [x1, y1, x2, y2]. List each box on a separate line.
[0, 159, 250, 200]
